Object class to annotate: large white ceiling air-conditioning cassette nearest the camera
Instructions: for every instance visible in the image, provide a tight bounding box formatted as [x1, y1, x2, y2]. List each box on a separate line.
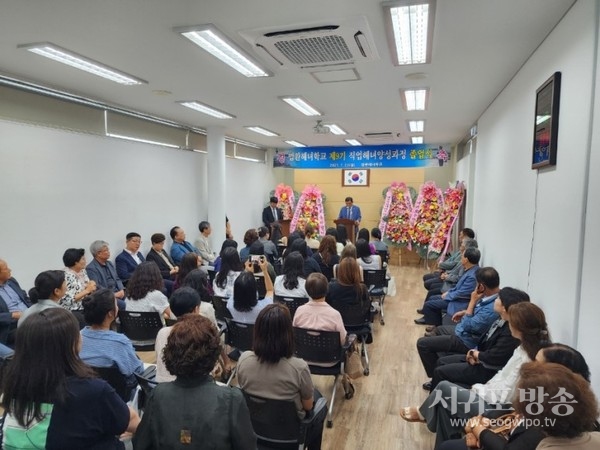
[240, 17, 379, 69]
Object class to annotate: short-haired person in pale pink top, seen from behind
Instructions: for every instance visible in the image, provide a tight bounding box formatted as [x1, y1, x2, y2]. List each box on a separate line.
[294, 273, 346, 345]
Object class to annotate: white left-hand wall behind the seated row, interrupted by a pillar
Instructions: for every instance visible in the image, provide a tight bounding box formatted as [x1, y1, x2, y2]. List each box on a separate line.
[0, 121, 273, 289]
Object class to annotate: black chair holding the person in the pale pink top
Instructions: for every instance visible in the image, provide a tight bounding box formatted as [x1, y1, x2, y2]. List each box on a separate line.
[294, 327, 356, 428]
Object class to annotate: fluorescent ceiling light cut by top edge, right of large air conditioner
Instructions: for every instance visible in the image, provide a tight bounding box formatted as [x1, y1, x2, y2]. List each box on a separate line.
[384, 0, 435, 66]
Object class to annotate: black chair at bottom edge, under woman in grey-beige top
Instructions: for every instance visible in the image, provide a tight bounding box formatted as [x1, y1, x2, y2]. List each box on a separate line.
[242, 391, 327, 450]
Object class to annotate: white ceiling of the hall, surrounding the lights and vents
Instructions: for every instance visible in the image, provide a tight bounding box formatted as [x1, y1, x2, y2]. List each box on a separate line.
[0, 0, 573, 148]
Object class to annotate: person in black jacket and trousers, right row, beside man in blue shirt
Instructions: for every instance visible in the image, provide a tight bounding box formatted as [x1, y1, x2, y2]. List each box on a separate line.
[432, 287, 529, 390]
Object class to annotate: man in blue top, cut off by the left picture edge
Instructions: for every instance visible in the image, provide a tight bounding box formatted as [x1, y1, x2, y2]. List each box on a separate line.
[0, 259, 31, 344]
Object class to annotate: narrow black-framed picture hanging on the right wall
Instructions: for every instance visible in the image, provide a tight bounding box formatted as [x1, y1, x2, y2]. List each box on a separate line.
[531, 72, 560, 169]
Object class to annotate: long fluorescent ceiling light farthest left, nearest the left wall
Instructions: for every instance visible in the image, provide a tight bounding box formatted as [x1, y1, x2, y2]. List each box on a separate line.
[17, 42, 147, 85]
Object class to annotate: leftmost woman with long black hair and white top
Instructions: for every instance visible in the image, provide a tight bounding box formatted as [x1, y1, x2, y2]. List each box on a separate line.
[125, 261, 171, 323]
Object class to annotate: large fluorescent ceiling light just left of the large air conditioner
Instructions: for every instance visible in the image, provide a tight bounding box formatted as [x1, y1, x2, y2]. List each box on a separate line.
[174, 24, 270, 78]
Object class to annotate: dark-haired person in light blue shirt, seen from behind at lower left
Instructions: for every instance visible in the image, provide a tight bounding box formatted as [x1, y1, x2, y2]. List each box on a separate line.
[79, 289, 144, 389]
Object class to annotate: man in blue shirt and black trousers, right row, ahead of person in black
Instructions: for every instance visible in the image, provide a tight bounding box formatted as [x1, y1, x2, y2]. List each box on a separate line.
[417, 267, 502, 387]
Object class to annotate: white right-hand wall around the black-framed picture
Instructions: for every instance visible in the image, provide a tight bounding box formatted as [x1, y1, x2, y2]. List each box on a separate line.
[471, 1, 600, 392]
